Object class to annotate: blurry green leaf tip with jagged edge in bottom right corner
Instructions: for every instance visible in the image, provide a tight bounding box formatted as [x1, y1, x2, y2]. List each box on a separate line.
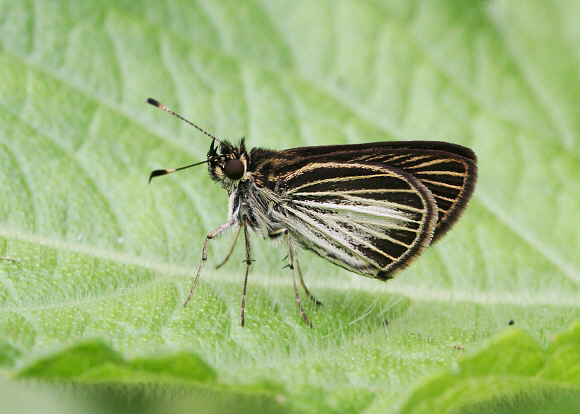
[386, 323, 580, 414]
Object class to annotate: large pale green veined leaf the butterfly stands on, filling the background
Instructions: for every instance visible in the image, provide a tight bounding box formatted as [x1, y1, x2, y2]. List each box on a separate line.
[0, 0, 580, 413]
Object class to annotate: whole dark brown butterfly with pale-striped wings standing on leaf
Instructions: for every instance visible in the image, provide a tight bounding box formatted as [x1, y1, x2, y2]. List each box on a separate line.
[147, 98, 477, 326]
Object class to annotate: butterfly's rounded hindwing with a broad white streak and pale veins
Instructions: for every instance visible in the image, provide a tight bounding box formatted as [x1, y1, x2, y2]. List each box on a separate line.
[260, 161, 437, 280]
